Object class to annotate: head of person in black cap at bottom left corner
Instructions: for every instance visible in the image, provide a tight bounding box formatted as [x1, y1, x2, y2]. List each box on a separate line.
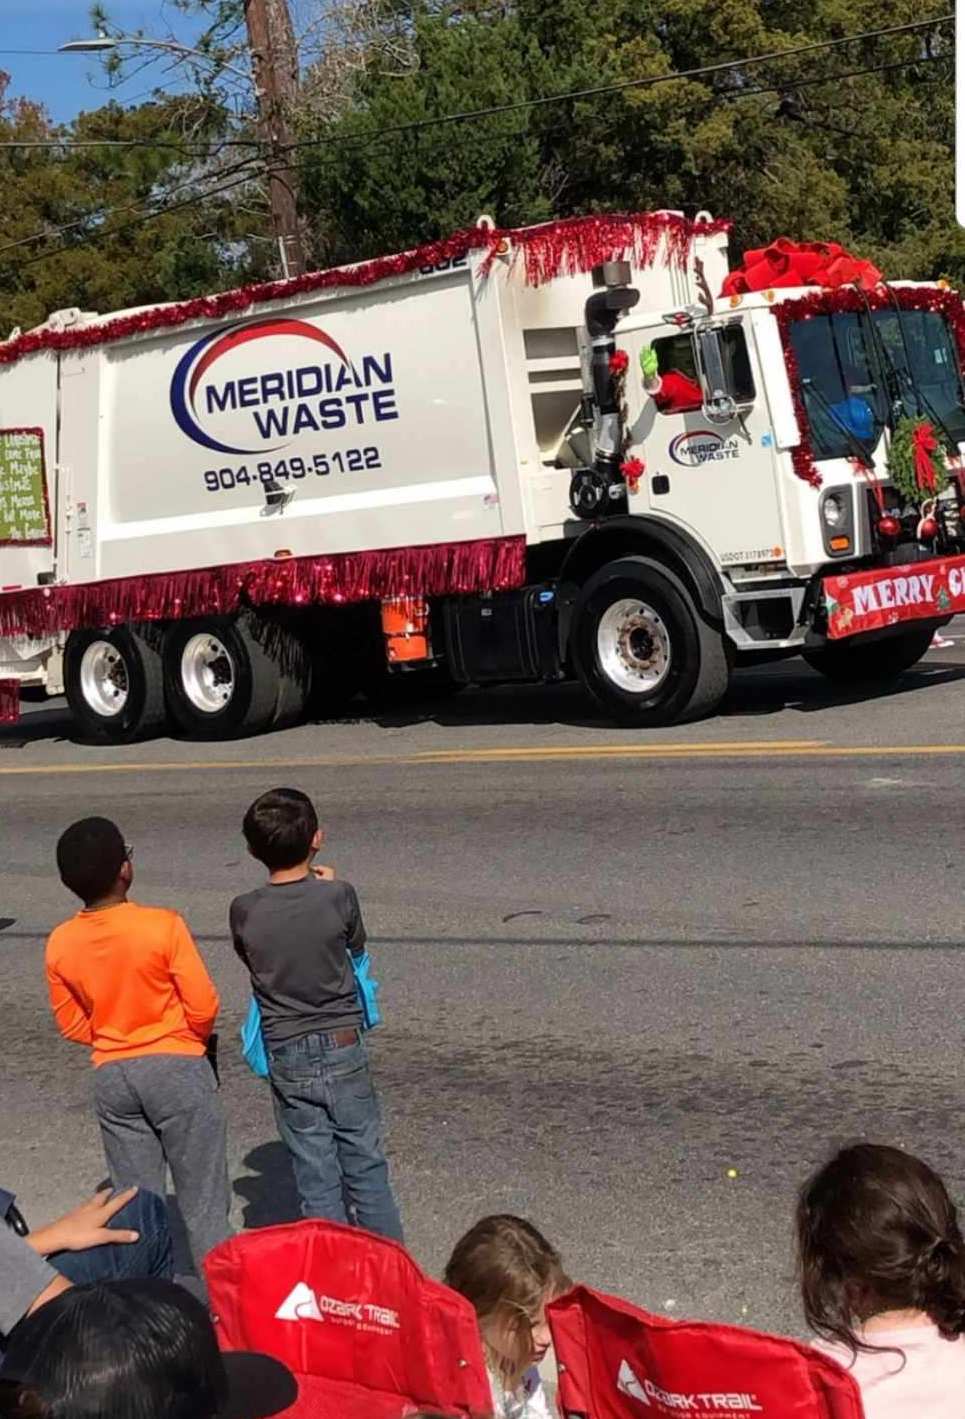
[0, 1280, 298, 1419]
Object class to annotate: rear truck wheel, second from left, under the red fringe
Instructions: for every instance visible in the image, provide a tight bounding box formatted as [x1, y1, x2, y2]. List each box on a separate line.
[165, 612, 281, 739]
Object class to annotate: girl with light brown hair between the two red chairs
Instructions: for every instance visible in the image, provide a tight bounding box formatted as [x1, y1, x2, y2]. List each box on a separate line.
[444, 1215, 570, 1419]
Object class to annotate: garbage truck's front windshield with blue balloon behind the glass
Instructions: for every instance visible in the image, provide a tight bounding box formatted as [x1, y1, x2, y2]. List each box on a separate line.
[790, 309, 965, 458]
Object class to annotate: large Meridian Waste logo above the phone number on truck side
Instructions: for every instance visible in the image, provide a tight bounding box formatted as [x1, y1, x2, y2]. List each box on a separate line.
[170, 316, 399, 455]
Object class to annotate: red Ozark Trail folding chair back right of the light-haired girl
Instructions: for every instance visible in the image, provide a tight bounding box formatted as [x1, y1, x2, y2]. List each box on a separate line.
[546, 1286, 864, 1419]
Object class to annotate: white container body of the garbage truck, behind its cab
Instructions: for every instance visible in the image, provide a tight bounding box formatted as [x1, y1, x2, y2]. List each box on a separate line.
[0, 218, 727, 586]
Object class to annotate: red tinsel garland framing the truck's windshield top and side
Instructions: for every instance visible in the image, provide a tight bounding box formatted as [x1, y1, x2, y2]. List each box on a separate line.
[773, 285, 965, 488]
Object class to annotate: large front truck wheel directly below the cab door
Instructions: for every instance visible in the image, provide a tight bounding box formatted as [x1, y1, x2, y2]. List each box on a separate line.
[570, 556, 731, 728]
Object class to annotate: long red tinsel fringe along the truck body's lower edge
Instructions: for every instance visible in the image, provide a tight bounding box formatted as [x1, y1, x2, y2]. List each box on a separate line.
[0, 536, 526, 637]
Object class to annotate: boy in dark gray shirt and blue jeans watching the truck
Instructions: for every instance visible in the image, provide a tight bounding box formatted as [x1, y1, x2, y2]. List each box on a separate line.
[228, 789, 402, 1242]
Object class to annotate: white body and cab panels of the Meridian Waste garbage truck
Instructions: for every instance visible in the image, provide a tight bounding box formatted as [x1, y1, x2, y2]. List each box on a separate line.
[0, 212, 962, 743]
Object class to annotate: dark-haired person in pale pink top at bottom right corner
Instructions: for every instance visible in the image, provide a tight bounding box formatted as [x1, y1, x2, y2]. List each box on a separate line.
[798, 1144, 965, 1419]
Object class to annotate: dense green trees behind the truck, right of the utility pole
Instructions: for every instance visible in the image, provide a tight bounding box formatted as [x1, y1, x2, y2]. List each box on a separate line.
[298, 0, 965, 281]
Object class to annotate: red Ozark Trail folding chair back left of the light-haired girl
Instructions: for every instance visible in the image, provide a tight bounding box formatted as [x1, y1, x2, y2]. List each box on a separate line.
[204, 1222, 492, 1419]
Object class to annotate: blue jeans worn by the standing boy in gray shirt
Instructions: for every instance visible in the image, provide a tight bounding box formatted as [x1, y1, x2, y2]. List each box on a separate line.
[268, 1034, 402, 1242]
